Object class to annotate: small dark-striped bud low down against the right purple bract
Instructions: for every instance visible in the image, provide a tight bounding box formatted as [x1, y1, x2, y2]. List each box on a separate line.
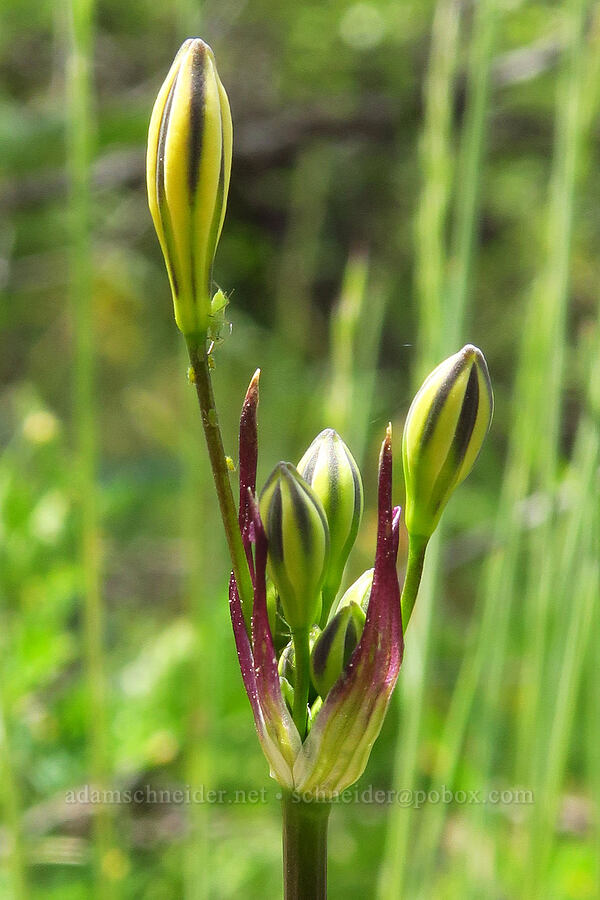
[310, 603, 365, 697]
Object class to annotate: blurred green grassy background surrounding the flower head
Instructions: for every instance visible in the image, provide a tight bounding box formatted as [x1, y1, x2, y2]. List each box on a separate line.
[0, 0, 600, 900]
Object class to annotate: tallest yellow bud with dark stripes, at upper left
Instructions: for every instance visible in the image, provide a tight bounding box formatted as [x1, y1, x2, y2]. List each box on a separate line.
[146, 38, 232, 336]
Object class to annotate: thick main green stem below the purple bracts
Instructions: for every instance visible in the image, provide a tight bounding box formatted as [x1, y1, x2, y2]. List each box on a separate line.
[283, 794, 331, 900]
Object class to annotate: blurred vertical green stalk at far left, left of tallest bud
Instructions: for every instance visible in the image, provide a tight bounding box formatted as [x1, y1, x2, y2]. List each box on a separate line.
[67, 0, 113, 897]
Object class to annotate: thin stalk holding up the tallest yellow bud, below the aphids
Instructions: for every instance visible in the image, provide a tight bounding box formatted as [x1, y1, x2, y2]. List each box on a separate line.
[187, 337, 254, 632]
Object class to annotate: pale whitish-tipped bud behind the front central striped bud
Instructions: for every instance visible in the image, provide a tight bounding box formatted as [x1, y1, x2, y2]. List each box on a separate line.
[298, 428, 364, 622]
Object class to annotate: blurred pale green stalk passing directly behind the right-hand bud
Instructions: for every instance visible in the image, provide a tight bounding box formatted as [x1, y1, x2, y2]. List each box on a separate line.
[378, 0, 464, 900]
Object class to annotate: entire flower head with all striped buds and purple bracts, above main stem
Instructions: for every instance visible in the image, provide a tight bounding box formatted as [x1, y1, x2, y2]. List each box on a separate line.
[147, 38, 493, 799]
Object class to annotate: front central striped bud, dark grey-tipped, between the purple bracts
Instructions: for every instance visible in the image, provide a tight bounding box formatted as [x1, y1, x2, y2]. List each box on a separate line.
[260, 462, 329, 631]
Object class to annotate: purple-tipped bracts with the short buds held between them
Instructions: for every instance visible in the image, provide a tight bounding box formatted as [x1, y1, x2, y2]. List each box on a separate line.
[230, 376, 403, 799]
